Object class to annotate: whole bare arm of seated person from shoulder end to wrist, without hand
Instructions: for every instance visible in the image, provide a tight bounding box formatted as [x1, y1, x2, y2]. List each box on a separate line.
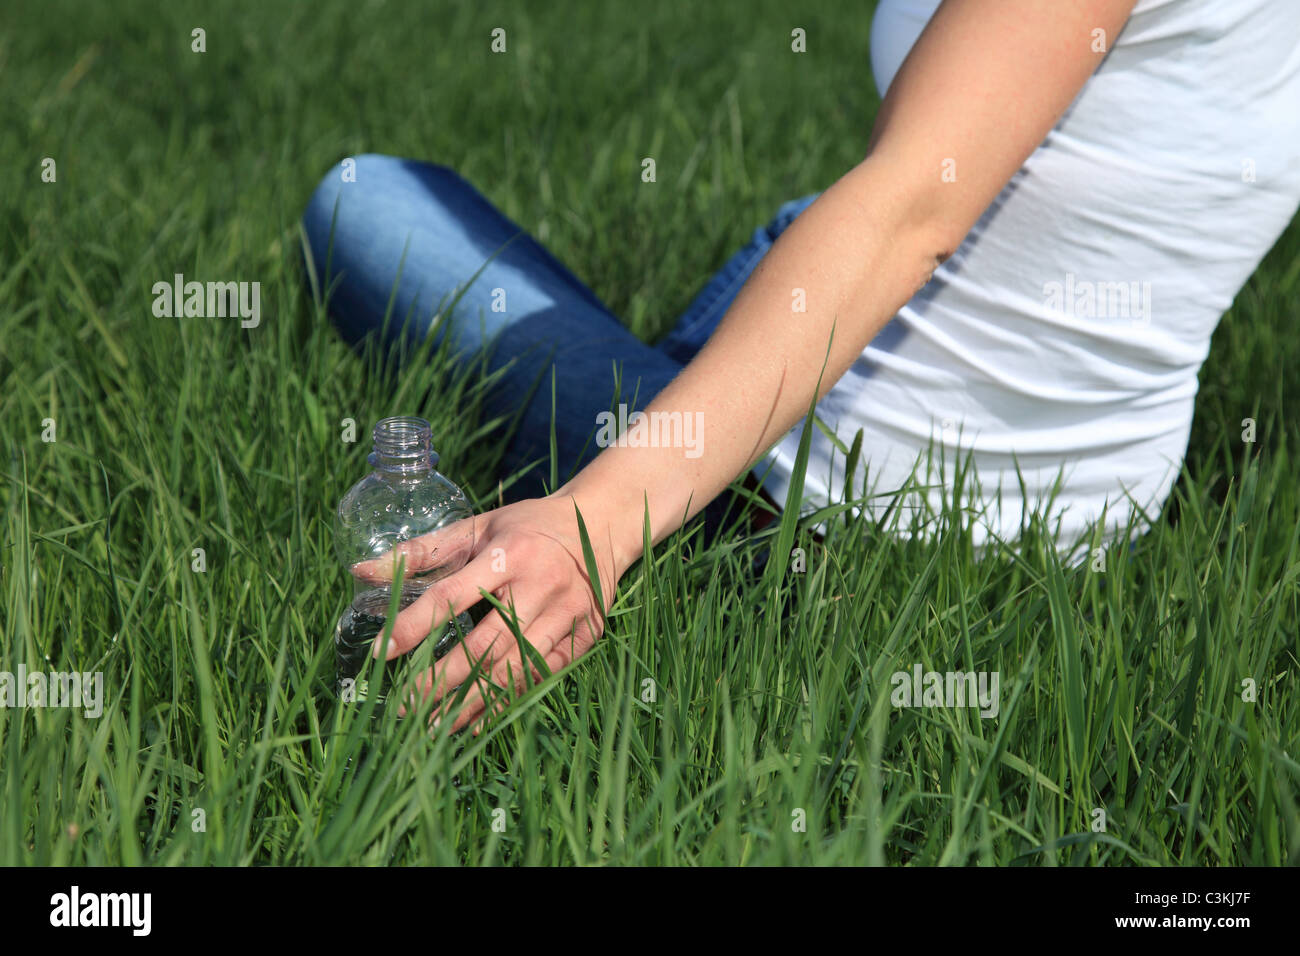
[556, 0, 1134, 574]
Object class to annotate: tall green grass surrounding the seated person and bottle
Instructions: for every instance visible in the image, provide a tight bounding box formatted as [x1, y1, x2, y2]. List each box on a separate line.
[0, 0, 1300, 865]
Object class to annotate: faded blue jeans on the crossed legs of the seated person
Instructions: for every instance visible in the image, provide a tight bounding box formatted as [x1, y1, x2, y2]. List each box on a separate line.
[303, 155, 816, 523]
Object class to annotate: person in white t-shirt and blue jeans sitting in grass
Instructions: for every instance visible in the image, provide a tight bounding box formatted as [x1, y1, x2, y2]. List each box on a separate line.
[304, 0, 1300, 727]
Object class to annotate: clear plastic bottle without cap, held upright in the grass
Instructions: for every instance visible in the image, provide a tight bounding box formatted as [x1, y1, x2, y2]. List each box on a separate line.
[334, 416, 475, 702]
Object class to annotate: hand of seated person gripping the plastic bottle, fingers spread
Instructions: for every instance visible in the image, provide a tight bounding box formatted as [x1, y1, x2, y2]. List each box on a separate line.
[352, 492, 631, 730]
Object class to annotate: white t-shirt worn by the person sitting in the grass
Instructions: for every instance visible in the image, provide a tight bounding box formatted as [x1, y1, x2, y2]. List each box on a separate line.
[755, 0, 1300, 558]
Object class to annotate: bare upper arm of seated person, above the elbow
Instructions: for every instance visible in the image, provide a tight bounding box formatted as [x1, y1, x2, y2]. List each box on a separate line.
[863, 0, 1136, 258]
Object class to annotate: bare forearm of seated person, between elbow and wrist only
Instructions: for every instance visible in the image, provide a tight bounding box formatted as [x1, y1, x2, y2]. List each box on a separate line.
[559, 159, 948, 572]
